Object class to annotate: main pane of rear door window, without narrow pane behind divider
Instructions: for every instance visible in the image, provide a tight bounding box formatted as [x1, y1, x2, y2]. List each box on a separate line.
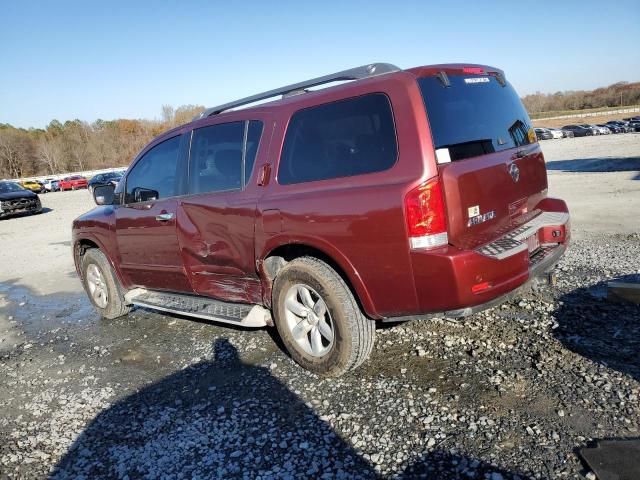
[189, 122, 245, 193]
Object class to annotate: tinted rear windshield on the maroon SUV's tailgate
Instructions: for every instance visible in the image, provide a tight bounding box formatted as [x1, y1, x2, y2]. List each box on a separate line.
[418, 75, 535, 161]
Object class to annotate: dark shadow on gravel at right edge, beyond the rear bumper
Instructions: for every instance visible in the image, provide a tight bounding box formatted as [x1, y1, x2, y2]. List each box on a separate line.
[555, 275, 640, 380]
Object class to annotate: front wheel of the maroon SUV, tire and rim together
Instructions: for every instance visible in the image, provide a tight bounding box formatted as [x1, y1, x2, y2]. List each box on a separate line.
[81, 248, 131, 319]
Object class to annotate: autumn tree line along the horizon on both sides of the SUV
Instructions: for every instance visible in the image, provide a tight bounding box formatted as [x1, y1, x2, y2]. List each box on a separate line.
[0, 82, 640, 179]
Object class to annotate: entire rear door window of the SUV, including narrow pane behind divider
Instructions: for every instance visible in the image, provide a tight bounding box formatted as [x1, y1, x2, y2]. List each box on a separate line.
[189, 120, 262, 193]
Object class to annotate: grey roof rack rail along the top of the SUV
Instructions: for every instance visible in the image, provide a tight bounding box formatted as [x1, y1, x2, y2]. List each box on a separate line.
[194, 63, 400, 120]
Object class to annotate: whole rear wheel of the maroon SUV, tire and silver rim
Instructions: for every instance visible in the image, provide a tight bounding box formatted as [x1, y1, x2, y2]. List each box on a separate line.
[272, 257, 375, 377]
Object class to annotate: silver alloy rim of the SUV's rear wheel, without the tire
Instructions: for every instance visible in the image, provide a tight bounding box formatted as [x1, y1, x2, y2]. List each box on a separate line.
[284, 283, 335, 357]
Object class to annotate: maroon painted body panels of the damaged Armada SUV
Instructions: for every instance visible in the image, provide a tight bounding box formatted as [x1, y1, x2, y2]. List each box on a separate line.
[74, 65, 569, 318]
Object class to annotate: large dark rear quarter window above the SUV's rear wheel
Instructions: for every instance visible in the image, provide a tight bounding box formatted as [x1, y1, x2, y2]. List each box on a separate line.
[278, 93, 398, 185]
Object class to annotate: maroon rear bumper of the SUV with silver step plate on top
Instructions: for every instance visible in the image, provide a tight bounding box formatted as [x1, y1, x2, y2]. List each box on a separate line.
[393, 199, 570, 317]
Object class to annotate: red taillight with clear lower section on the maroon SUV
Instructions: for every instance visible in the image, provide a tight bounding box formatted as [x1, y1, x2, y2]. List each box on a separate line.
[404, 178, 449, 249]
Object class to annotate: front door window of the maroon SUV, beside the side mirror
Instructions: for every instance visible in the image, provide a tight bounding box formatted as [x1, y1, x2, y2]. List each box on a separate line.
[125, 136, 180, 203]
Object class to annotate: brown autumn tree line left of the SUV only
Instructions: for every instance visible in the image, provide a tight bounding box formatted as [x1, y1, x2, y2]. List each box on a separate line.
[0, 105, 204, 179]
